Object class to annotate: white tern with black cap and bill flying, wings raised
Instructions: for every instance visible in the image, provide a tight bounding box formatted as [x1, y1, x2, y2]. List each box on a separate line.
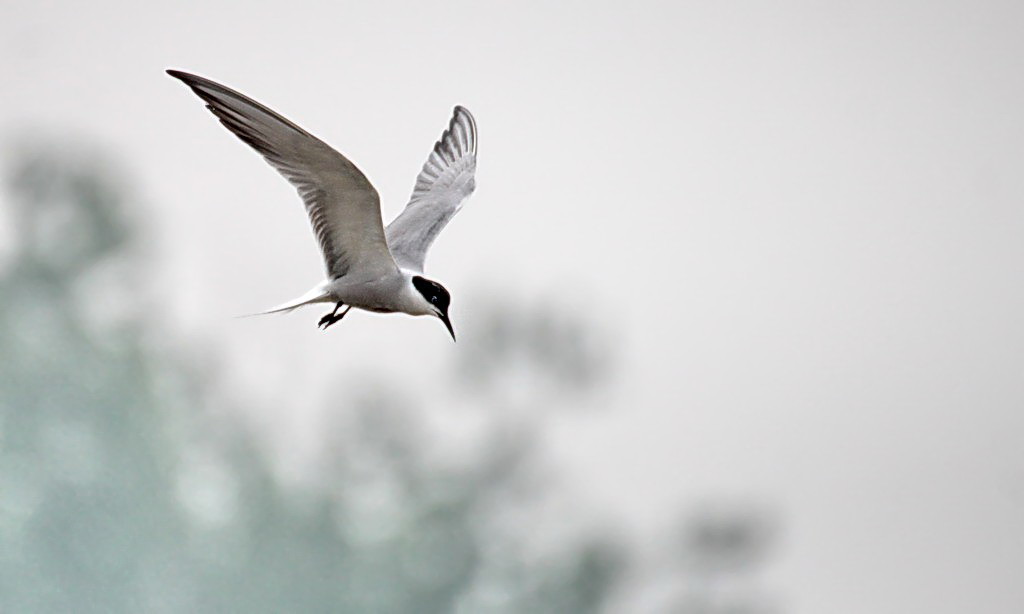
[167, 70, 476, 341]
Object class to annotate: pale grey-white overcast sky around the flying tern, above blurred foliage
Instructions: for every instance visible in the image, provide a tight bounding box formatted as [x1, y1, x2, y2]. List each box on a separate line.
[0, 1, 1024, 614]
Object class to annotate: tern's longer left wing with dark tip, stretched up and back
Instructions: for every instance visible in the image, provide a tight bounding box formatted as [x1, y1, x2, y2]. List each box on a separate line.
[167, 71, 395, 278]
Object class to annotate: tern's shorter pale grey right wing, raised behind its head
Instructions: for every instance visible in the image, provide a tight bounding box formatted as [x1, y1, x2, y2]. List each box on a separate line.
[385, 106, 476, 272]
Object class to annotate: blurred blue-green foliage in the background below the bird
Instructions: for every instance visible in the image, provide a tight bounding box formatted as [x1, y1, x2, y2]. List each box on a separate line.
[0, 148, 764, 614]
